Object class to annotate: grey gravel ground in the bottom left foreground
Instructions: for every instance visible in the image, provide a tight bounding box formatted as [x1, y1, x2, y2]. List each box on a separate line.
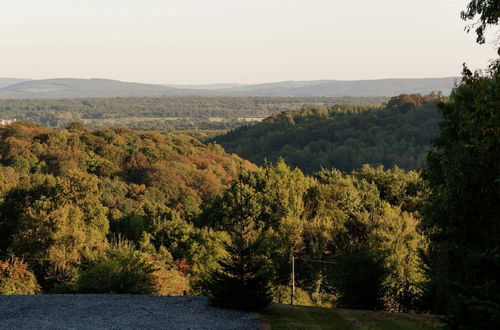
[0, 295, 261, 330]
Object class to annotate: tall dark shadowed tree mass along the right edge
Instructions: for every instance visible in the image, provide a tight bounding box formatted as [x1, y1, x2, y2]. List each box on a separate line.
[425, 64, 500, 328]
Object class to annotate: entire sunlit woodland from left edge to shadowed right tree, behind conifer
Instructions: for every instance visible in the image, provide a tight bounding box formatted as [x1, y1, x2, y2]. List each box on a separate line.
[0, 122, 427, 311]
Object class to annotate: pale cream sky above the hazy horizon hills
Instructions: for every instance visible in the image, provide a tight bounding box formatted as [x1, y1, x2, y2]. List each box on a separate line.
[0, 0, 496, 84]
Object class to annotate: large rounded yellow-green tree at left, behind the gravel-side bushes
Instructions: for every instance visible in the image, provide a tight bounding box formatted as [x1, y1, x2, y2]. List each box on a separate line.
[1, 172, 108, 282]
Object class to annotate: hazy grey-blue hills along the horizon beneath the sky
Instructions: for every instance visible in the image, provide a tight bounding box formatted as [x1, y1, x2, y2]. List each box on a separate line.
[0, 77, 458, 99]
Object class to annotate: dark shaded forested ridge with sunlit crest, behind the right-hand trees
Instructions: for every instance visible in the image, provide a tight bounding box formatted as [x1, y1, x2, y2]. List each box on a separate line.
[215, 94, 441, 173]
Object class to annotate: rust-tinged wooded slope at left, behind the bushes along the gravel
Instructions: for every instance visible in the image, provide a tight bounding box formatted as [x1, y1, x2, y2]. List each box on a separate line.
[0, 122, 250, 292]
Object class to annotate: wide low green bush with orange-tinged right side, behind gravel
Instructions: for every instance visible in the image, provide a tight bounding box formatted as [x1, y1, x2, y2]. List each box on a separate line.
[75, 241, 189, 295]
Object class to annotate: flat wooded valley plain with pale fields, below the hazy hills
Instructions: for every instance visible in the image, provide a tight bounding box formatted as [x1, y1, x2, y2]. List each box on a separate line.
[0, 96, 388, 129]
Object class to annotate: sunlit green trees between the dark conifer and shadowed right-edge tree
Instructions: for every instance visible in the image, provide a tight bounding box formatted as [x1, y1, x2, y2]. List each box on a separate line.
[201, 161, 427, 311]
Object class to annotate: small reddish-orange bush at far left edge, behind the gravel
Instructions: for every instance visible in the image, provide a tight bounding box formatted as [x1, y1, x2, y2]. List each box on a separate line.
[0, 257, 40, 295]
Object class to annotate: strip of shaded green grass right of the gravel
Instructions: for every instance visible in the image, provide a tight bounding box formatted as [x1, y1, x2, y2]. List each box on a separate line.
[259, 304, 443, 330]
